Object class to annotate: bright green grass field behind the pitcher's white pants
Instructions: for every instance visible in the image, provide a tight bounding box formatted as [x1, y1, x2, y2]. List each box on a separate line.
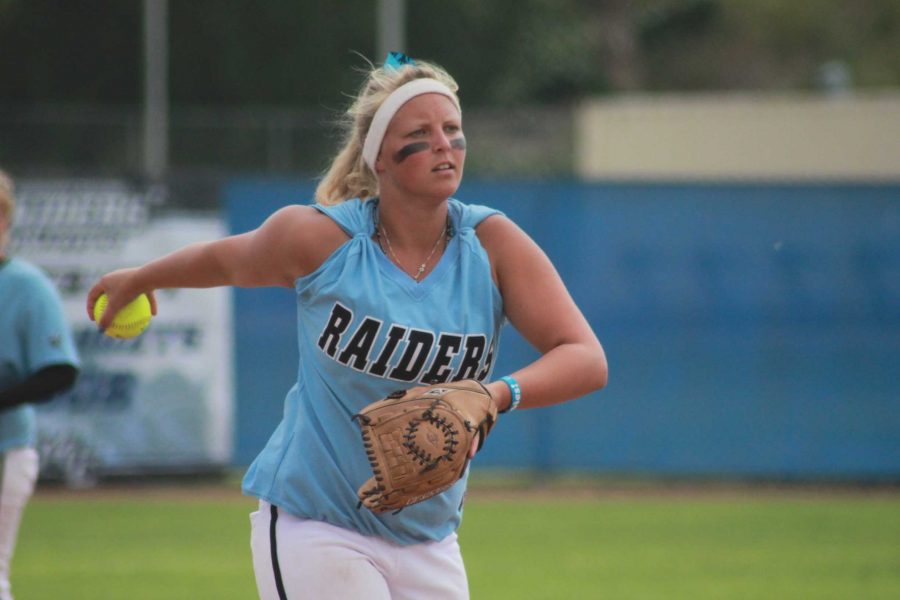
[12, 485, 900, 600]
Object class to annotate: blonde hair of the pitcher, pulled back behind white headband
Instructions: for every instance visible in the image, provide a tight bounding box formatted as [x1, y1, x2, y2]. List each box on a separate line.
[316, 60, 459, 205]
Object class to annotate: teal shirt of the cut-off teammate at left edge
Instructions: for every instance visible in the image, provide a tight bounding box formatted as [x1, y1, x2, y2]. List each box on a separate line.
[0, 258, 78, 452]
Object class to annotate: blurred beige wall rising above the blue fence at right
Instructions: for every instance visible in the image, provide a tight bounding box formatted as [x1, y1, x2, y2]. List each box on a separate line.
[574, 93, 900, 182]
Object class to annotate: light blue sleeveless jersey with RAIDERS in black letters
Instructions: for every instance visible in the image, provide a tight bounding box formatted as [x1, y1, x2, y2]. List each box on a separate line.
[243, 199, 504, 544]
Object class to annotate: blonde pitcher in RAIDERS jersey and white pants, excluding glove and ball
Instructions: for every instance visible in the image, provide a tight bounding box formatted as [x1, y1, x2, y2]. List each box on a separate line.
[87, 54, 607, 600]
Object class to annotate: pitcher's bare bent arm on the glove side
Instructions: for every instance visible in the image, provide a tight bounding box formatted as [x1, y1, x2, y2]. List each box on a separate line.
[477, 215, 607, 410]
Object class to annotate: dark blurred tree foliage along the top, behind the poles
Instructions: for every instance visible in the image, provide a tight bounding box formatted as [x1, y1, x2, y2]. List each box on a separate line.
[0, 0, 900, 108]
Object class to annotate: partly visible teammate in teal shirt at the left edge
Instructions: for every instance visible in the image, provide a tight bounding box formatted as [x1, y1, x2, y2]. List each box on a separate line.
[0, 171, 78, 600]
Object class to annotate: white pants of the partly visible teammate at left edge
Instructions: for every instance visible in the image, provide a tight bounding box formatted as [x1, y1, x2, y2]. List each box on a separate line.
[0, 448, 38, 600]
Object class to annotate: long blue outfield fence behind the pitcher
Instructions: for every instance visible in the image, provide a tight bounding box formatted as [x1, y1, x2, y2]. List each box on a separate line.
[225, 180, 900, 480]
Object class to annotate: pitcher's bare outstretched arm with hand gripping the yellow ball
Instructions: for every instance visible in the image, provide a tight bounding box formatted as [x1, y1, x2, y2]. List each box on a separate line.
[87, 205, 347, 328]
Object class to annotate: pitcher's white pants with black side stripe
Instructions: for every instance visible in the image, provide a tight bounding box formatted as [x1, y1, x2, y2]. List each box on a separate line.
[250, 502, 469, 600]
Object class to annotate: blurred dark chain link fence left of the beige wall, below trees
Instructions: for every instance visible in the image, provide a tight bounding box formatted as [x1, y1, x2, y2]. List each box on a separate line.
[0, 105, 574, 190]
